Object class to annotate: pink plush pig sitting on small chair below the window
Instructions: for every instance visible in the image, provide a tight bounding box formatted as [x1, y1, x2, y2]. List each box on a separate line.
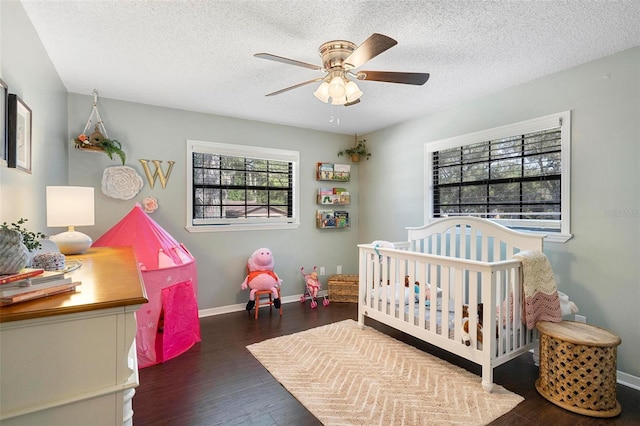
[240, 248, 282, 311]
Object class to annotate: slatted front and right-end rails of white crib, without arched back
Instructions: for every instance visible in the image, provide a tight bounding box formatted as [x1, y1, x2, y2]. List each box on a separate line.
[358, 243, 535, 386]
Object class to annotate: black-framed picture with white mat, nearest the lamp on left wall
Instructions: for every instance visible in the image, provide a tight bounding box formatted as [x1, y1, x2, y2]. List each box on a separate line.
[7, 94, 32, 173]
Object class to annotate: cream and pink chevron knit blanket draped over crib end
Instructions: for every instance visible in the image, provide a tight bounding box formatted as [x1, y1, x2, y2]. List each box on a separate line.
[513, 251, 562, 330]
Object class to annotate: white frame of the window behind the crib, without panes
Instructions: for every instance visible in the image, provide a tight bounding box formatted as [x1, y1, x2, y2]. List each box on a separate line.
[424, 111, 572, 243]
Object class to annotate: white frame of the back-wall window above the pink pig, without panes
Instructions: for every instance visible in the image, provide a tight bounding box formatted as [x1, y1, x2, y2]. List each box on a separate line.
[185, 140, 300, 232]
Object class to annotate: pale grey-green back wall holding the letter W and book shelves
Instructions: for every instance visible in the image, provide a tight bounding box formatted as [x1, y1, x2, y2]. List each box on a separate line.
[67, 94, 358, 310]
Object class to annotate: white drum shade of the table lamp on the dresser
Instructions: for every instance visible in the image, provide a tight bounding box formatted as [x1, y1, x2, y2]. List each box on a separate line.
[47, 186, 95, 227]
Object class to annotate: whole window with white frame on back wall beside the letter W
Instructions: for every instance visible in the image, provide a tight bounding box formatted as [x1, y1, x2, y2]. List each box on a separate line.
[187, 141, 300, 232]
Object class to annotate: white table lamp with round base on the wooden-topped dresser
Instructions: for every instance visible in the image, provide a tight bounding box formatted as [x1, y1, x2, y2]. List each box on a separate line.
[47, 186, 95, 254]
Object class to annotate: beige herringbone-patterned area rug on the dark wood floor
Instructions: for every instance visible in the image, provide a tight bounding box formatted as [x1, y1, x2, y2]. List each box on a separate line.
[247, 320, 524, 426]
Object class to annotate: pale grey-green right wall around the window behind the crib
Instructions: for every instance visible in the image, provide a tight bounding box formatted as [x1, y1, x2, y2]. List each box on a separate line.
[358, 48, 640, 376]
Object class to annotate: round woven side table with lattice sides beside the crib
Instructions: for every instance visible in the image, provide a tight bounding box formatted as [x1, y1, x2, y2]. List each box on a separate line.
[536, 321, 622, 417]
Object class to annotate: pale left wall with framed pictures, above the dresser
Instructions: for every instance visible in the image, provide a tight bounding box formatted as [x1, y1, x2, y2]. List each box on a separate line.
[0, 1, 67, 240]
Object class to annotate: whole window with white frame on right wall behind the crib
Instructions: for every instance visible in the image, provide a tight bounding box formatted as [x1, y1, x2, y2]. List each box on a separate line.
[425, 111, 571, 241]
